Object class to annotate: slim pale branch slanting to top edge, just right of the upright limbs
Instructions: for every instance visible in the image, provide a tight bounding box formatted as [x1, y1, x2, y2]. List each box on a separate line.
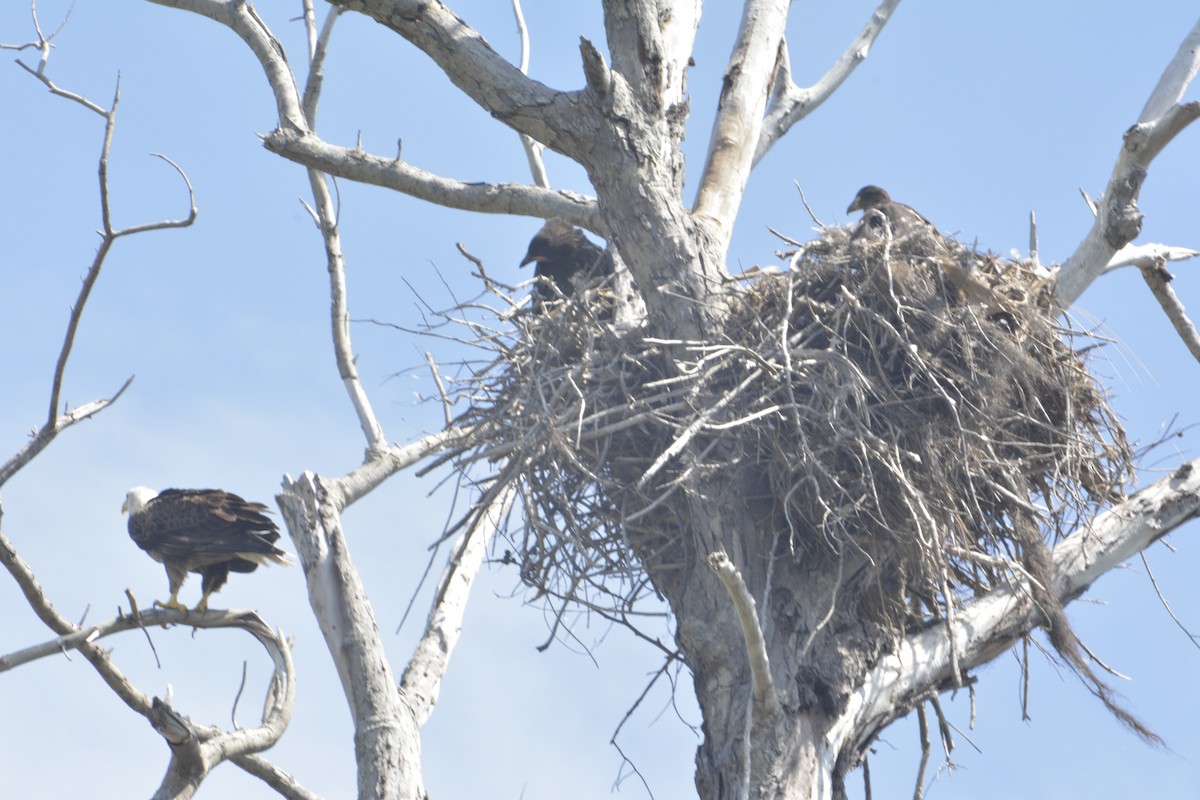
[754, 0, 900, 164]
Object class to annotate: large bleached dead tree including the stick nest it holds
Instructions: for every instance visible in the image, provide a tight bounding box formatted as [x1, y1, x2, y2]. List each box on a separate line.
[10, 0, 1200, 800]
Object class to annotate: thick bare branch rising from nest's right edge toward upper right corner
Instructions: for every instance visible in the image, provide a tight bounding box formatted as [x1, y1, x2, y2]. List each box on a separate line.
[1055, 22, 1200, 306]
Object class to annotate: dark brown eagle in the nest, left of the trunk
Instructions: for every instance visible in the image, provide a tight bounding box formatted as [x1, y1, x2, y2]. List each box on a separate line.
[521, 217, 613, 309]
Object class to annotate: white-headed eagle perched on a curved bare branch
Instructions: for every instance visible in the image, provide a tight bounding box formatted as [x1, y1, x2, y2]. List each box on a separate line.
[121, 486, 290, 612]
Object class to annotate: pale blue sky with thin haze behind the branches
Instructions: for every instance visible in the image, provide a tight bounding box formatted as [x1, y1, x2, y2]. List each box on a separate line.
[0, 0, 1200, 800]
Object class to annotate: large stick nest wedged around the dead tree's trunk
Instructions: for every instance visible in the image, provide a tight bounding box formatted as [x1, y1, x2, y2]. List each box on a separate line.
[446, 229, 1132, 628]
